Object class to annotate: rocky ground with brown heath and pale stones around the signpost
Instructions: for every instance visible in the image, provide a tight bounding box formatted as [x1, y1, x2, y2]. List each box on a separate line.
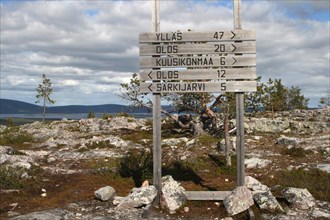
[0, 108, 330, 219]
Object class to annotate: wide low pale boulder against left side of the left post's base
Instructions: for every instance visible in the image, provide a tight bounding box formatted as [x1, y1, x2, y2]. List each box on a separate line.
[118, 186, 158, 208]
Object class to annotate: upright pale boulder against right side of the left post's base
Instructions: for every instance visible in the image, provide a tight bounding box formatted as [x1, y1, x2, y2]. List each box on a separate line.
[161, 176, 187, 213]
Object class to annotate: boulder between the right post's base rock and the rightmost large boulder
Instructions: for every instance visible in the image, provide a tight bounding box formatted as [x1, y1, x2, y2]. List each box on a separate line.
[253, 191, 284, 212]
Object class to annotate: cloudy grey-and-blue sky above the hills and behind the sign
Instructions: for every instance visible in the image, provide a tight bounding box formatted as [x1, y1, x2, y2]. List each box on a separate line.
[0, 0, 330, 107]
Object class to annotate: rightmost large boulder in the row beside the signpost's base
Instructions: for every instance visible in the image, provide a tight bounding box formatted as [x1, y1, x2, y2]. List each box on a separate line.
[283, 187, 315, 210]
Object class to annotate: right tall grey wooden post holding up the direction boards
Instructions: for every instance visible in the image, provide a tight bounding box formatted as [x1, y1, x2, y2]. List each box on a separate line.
[234, 0, 245, 186]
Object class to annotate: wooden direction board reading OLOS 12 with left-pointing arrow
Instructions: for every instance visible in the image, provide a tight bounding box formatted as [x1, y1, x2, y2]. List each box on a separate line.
[140, 67, 257, 81]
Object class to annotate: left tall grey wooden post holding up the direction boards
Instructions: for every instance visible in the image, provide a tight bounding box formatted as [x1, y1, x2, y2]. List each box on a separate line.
[152, 0, 162, 206]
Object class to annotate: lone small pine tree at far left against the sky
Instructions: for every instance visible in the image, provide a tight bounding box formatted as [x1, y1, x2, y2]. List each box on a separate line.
[36, 74, 55, 121]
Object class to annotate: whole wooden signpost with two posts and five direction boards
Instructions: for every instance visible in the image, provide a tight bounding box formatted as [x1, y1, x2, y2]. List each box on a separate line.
[139, 0, 257, 215]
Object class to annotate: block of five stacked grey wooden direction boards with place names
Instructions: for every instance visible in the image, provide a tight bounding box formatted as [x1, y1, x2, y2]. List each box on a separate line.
[139, 30, 257, 93]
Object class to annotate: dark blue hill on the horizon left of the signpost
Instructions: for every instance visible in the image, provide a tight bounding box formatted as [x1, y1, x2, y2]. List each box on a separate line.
[0, 99, 148, 114]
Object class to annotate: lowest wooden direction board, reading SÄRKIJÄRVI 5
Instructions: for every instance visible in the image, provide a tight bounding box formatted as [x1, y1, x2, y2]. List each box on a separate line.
[140, 81, 257, 93]
